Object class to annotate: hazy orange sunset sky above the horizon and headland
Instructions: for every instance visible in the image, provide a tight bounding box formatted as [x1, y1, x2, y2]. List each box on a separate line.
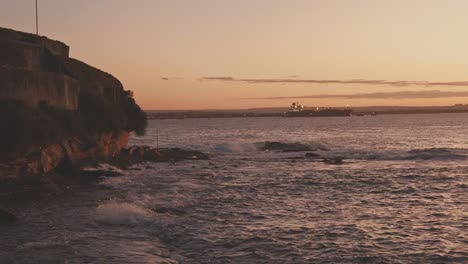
[0, 0, 468, 110]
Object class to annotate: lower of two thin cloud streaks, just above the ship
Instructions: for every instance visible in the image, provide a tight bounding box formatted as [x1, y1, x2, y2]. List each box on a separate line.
[243, 90, 468, 100]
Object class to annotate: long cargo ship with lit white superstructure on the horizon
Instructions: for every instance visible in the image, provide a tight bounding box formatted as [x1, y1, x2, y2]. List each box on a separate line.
[284, 102, 353, 117]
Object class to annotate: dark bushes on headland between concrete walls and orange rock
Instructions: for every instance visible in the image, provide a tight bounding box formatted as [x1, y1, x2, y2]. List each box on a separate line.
[0, 94, 147, 157]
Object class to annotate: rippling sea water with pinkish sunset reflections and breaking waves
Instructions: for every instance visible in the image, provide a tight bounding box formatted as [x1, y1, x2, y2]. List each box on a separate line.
[0, 114, 468, 263]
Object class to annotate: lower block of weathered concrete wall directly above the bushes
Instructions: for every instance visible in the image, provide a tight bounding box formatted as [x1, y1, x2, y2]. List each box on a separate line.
[0, 68, 80, 110]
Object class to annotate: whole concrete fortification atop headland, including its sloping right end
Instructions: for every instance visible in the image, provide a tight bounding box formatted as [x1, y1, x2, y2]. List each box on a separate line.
[0, 28, 123, 109]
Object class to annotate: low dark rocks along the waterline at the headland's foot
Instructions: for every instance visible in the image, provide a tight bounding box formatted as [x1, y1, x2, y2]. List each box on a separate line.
[0, 146, 211, 224]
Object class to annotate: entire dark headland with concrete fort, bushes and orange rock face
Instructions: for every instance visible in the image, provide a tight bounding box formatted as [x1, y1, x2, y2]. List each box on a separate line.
[0, 28, 147, 178]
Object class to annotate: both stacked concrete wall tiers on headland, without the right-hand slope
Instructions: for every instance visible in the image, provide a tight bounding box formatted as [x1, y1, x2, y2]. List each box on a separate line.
[0, 28, 80, 110]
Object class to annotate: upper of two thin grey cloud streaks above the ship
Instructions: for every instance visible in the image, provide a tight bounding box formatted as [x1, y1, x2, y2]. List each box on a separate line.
[198, 77, 468, 87]
